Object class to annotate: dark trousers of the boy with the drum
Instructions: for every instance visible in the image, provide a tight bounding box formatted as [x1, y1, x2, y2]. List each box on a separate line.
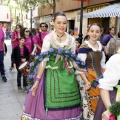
[17, 69, 28, 87]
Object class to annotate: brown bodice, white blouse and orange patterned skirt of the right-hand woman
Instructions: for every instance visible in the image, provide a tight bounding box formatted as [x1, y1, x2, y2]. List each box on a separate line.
[77, 41, 105, 120]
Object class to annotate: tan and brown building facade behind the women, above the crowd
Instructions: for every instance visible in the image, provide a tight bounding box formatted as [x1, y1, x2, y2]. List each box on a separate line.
[33, 0, 120, 36]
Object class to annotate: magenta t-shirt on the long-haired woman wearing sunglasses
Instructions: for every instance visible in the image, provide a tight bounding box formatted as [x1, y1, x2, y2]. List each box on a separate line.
[25, 37, 36, 54]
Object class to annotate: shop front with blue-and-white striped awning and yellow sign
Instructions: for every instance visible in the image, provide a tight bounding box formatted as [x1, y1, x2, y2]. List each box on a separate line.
[83, 3, 120, 31]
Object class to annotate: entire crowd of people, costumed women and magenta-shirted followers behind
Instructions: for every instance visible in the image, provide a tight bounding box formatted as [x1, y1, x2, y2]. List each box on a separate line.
[0, 12, 120, 120]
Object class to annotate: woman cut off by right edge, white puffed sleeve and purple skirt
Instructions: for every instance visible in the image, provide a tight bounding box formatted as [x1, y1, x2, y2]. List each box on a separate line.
[94, 49, 120, 120]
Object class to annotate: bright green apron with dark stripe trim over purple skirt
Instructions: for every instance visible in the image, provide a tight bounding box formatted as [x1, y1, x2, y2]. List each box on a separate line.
[44, 57, 80, 109]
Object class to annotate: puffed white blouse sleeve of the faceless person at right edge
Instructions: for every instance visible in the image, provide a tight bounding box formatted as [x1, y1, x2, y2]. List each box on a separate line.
[99, 54, 120, 90]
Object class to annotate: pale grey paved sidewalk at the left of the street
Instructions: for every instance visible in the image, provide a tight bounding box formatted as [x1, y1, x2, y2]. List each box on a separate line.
[0, 40, 26, 120]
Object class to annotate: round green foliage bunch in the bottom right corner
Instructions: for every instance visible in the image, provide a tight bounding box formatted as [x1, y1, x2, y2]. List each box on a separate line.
[109, 101, 120, 117]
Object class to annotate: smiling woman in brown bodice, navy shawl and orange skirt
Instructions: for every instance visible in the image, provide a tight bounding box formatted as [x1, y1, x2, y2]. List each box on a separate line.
[76, 23, 105, 120]
